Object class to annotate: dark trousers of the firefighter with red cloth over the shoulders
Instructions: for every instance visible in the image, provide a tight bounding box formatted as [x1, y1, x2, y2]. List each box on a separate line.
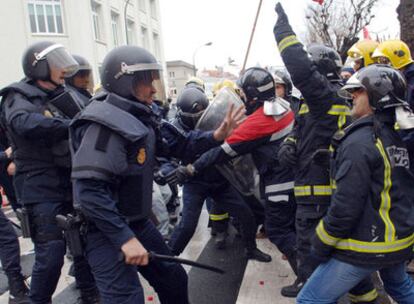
[265, 194, 296, 258]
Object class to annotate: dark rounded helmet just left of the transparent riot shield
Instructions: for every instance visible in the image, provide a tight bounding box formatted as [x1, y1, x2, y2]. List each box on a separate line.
[177, 87, 209, 130]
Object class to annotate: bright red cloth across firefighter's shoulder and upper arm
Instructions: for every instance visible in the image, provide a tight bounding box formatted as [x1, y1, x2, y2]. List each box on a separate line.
[226, 107, 295, 144]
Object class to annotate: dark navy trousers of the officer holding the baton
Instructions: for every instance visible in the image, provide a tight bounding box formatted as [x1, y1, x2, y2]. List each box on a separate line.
[86, 220, 188, 304]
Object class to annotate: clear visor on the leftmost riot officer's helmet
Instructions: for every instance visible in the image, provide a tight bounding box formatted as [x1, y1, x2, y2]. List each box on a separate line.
[42, 45, 79, 77]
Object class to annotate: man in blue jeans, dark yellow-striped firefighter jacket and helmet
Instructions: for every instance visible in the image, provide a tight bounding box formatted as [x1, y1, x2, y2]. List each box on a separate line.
[297, 65, 414, 304]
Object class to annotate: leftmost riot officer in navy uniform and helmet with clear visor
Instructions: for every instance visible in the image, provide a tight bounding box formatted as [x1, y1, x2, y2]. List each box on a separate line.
[1, 41, 99, 304]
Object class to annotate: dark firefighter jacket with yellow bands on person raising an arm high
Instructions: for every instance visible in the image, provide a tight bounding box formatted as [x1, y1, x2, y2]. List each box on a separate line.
[275, 19, 350, 204]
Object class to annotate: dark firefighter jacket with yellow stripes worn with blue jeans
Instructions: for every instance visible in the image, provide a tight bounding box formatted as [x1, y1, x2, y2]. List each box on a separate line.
[312, 115, 414, 266]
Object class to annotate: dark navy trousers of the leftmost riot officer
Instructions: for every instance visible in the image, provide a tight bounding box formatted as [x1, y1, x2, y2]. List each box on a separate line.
[28, 202, 95, 304]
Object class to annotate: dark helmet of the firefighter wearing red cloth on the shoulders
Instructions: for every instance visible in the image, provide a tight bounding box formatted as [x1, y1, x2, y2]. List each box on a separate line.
[237, 67, 276, 115]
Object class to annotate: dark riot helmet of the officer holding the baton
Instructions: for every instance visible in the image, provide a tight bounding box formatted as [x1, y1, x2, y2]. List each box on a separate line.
[101, 45, 162, 99]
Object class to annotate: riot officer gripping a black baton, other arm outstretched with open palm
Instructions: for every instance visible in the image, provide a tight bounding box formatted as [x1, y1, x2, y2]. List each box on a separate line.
[71, 46, 241, 304]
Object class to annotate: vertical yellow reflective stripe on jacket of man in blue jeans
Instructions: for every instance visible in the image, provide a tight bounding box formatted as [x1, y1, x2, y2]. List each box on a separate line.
[375, 138, 395, 241]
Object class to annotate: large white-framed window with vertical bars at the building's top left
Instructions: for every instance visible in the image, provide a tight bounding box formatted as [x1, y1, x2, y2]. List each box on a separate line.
[27, 0, 63, 34]
